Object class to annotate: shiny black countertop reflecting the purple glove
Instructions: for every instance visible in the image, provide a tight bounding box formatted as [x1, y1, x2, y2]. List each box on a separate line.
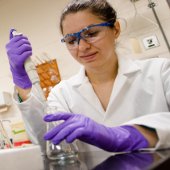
[45, 150, 170, 170]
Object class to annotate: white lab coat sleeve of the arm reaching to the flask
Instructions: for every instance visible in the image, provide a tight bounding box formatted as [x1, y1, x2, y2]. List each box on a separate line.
[125, 61, 170, 149]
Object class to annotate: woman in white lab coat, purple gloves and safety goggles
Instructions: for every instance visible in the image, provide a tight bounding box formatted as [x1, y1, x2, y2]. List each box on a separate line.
[6, 0, 170, 152]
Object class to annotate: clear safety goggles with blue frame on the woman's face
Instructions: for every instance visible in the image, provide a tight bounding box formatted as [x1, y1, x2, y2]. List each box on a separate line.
[61, 22, 113, 50]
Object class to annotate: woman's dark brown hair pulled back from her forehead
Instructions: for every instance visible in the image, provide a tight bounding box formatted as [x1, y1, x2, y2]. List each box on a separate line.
[60, 0, 117, 33]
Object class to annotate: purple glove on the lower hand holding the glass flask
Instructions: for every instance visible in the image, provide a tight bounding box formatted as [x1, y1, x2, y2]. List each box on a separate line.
[44, 113, 148, 152]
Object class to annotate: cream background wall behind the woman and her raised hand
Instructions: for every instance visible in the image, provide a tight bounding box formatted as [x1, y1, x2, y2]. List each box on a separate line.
[0, 0, 170, 119]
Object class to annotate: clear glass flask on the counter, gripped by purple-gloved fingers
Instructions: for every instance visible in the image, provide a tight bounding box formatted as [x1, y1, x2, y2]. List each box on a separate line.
[46, 106, 78, 165]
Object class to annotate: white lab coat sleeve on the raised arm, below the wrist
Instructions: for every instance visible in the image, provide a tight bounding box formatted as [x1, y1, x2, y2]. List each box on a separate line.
[14, 89, 46, 153]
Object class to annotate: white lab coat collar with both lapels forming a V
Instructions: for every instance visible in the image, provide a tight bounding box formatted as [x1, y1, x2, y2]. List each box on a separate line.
[70, 55, 140, 114]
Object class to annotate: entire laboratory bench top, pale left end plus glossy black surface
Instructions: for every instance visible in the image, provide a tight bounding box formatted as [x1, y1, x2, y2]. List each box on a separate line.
[0, 146, 170, 170]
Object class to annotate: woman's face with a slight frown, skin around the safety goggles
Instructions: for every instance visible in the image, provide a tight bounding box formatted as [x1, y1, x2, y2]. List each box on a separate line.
[62, 11, 120, 69]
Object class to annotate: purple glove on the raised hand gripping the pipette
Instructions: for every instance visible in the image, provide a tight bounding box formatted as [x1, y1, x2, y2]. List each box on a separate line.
[6, 29, 32, 89]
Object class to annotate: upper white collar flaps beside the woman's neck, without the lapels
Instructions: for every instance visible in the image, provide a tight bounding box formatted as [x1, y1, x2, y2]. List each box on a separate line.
[71, 56, 141, 86]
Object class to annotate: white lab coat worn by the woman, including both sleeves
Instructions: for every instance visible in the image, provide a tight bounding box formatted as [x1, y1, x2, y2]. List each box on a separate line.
[18, 57, 170, 153]
